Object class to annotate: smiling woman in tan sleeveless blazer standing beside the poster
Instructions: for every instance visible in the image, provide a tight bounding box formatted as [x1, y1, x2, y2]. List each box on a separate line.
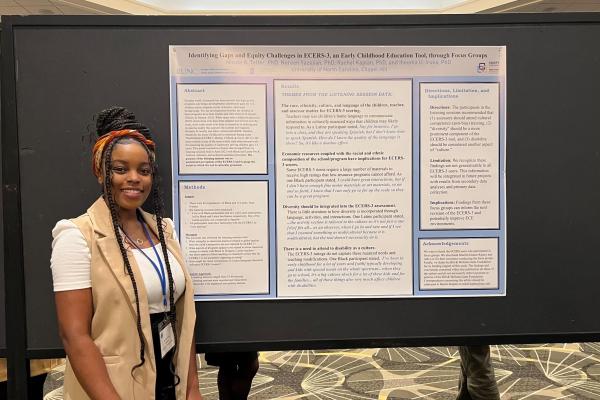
[51, 107, 201, 400]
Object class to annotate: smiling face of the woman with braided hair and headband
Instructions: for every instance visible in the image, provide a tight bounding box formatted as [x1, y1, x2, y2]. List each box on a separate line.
[99, 140, 152, 213]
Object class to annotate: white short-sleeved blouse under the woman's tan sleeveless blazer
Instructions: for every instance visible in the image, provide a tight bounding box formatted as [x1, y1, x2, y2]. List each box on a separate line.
[50, 218, 185, 314]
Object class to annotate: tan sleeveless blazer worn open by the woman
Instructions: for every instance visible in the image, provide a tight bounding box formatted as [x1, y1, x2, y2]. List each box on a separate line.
[64, 198, 196, 400]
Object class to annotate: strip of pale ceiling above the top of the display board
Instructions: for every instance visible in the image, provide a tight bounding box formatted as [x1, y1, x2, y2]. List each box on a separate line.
[0, 0, 600, 15]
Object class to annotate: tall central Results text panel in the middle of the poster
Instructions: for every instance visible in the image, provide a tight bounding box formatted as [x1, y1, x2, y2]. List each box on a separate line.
[274, 80, 412, 297]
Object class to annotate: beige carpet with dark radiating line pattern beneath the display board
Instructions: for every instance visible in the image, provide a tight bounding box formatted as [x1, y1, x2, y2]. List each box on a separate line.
[44, 343, 600, 400]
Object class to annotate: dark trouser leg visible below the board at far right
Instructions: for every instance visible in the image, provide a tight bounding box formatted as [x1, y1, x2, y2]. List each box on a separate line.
[456, 345, 500, 400]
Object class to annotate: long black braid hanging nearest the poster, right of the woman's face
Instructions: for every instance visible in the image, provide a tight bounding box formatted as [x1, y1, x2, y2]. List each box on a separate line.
[152, 173, 181, 386]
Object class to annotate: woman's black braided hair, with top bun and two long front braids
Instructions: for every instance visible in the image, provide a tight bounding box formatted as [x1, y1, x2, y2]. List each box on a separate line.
[96, 106, 180, 385]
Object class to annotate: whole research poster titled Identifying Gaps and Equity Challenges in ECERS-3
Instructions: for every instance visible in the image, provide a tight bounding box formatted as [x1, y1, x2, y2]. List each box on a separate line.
[169, 45, 506, 301]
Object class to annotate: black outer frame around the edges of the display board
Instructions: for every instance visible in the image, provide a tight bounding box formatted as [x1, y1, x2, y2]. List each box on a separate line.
[0, 13, 600, 398]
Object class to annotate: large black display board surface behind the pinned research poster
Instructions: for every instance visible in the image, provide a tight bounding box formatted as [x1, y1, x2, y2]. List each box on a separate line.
[2, 14, 600, 357]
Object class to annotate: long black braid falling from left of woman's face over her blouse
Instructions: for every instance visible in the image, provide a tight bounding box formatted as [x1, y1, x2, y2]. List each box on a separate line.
[104, 140, 146, 374]
